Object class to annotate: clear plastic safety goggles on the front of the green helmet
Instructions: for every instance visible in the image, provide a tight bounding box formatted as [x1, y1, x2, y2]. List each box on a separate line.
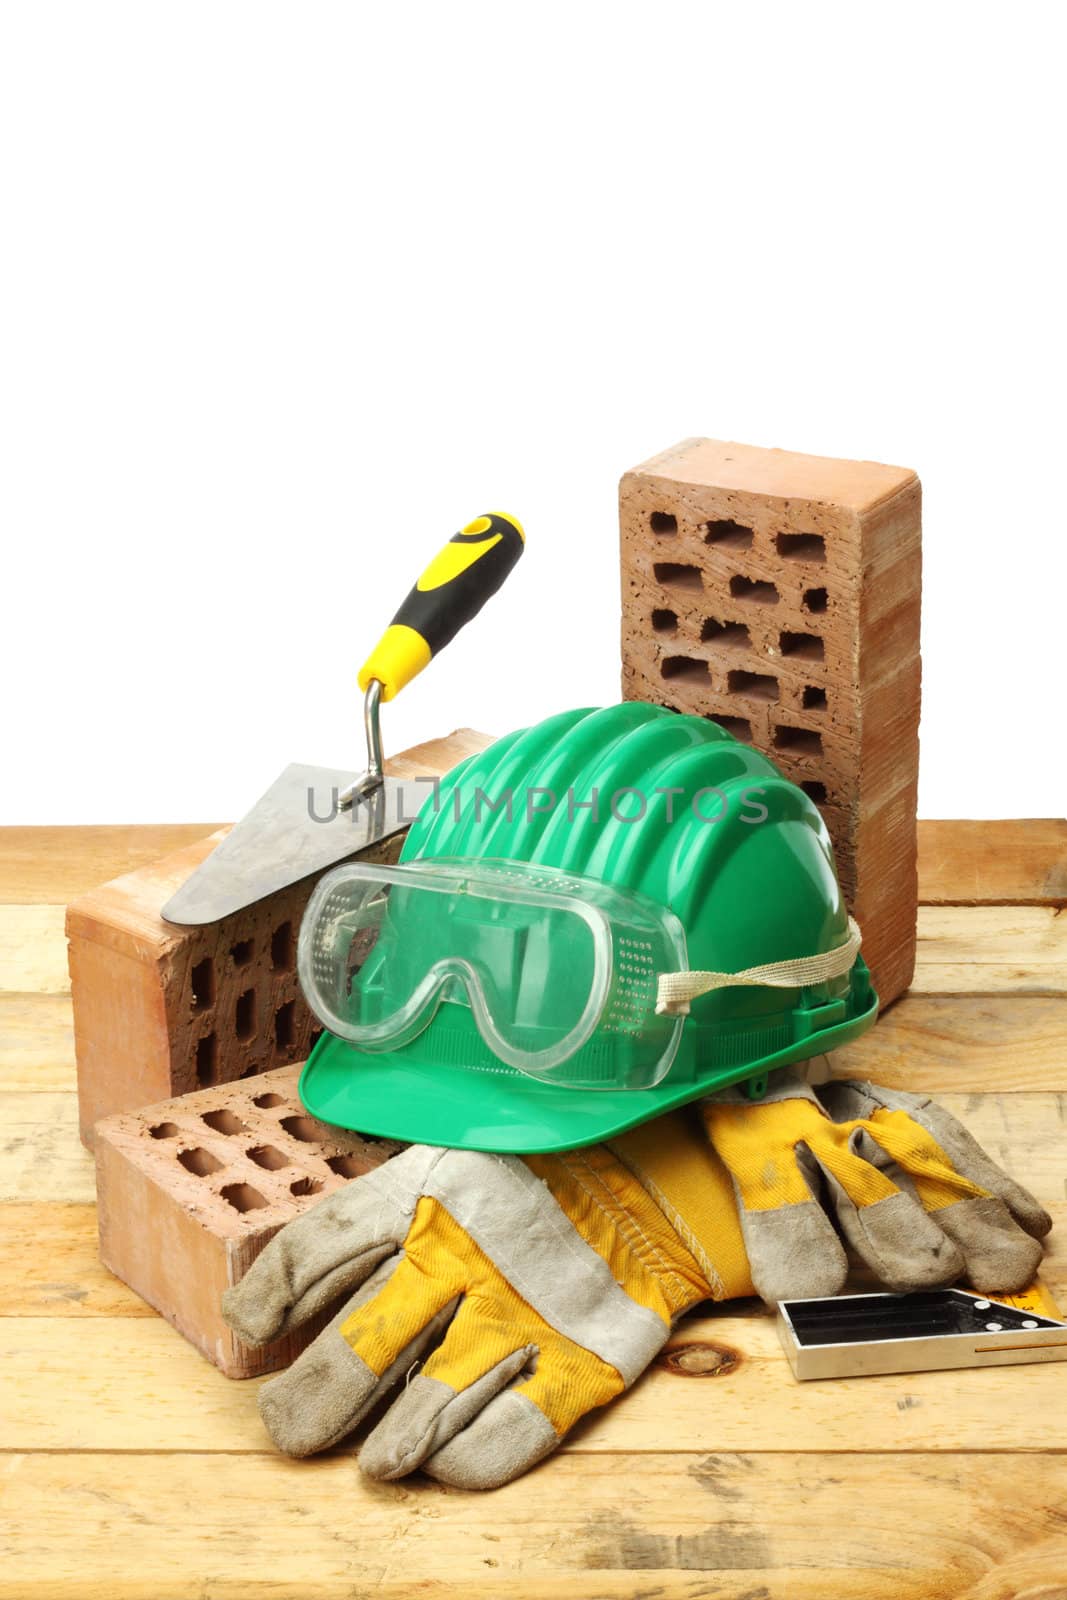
[298, 861, 686, 1088]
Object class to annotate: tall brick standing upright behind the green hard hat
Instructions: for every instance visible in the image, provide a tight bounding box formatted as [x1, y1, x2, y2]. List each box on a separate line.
[619, 438, 921, 1005]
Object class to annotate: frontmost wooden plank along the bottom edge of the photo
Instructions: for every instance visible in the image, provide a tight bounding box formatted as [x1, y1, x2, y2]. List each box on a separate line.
[0, 1450, 1067, 1600]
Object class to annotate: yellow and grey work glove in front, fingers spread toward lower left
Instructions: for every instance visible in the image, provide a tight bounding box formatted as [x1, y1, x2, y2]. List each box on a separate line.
[222, 1114, 752, 1488]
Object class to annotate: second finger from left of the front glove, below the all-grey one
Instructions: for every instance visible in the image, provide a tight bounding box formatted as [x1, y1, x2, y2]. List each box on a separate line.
[259, 1256, 459, 1456]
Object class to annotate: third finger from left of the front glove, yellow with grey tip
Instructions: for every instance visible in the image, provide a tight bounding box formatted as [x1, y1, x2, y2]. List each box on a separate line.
[360, 1302, 537, 1478]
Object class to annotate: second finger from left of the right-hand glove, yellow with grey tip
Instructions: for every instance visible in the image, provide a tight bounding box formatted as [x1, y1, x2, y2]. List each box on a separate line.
[797, 1128, 963, 1293]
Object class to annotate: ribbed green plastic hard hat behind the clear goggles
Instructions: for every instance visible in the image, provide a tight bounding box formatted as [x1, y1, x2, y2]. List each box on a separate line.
[301, 701, 878, 1154]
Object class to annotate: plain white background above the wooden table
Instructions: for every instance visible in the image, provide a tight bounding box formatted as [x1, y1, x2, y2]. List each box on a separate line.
[0, 0, 1067, 822]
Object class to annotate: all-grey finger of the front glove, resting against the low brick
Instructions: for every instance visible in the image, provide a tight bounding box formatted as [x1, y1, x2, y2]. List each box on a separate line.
[222, 1146, 442, 1346]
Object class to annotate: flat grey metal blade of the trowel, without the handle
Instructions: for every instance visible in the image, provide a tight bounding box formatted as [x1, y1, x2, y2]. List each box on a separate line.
[163, 763, 435, 926]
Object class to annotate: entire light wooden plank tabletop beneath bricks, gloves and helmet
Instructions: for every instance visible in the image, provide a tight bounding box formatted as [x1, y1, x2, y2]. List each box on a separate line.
[0, 824, 1067, 1600]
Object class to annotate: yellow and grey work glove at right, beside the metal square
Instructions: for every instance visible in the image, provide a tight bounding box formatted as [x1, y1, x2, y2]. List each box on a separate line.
[701, 1072, 1053, 1304]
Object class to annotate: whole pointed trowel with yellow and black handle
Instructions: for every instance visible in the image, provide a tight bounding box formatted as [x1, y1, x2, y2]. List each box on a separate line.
[163, 512, 526, 926]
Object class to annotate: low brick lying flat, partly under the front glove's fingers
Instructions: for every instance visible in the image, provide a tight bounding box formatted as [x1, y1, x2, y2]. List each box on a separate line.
[94, 1066, 398, 1378]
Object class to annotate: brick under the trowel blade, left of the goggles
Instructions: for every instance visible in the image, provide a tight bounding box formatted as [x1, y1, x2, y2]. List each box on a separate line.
[67, 730, 488, 1146]
